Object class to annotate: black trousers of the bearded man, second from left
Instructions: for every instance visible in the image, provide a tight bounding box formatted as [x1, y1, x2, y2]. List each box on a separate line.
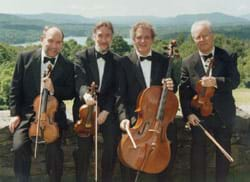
[73, 113, 120, 182]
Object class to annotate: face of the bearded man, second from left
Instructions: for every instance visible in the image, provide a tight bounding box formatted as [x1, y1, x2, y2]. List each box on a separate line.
[93, 26, 112, 52]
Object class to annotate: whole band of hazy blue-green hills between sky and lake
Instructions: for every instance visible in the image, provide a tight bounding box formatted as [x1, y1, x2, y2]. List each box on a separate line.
[0, 13, 250, 44]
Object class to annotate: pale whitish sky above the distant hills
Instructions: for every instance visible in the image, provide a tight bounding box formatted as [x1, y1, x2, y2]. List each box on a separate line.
[0, 0, 250, 17]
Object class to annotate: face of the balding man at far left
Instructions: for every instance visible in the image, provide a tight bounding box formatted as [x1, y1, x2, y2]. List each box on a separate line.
[41, 28, 63, 57]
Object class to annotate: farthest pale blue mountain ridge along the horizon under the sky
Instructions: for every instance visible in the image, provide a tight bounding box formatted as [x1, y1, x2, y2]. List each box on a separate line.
[13, 12, 250, 26]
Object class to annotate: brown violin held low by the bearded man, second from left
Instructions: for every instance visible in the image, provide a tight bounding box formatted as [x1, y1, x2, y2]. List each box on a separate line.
[74, 82, 97, 137]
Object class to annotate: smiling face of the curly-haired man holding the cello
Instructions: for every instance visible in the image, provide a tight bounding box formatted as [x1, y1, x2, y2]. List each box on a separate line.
[133, 28, 153, 56]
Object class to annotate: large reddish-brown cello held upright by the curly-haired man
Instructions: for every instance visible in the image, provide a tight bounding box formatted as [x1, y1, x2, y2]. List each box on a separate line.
[118, 41, 178, 174]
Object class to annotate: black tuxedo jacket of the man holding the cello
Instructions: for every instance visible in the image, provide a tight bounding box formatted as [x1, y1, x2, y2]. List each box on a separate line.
[117, 51, 175, 123]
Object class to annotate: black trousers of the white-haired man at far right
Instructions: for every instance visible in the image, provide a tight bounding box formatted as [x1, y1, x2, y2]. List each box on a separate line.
[191, 114, 232, 182]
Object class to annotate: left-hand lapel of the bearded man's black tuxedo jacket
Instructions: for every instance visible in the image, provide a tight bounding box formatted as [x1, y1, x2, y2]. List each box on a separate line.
[88, 47, 100, 85]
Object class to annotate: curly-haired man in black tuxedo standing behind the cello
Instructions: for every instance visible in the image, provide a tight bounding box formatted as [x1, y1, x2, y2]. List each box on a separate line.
[117, 22, 176, 182]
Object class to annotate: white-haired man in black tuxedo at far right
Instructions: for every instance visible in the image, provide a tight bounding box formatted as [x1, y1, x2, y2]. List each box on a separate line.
[179, 21, 240, 182]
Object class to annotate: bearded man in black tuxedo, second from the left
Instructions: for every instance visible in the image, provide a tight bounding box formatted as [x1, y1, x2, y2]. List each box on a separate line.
[73, 21, 120, 182]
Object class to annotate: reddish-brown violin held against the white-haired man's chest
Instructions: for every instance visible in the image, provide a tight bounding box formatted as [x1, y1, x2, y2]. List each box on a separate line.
[191, 57, 215, 117]
